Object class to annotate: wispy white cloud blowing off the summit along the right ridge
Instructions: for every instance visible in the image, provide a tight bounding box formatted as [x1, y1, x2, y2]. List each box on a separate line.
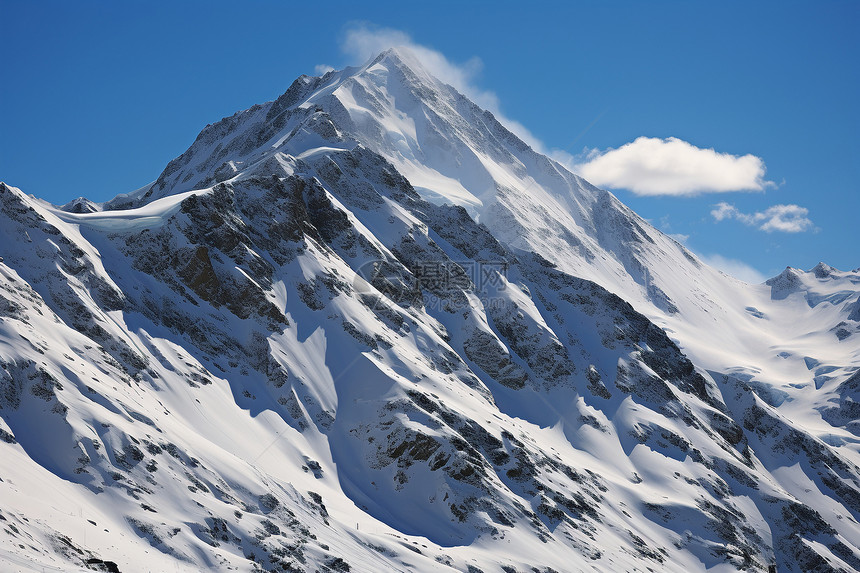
[341, 24, 546, 153]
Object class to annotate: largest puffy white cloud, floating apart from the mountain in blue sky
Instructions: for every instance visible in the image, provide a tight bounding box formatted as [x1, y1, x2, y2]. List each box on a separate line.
[574, 137, 776, 195]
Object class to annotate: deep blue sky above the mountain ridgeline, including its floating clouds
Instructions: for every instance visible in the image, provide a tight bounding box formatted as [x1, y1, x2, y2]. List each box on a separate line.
[0, 0, 860, 278]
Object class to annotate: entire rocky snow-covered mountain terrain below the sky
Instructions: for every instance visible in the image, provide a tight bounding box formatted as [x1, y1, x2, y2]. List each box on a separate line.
[5, 50, 860, 573]
